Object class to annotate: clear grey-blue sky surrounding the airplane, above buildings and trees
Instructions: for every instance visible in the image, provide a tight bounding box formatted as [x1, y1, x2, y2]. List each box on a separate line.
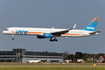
[0, 0, 105, 54]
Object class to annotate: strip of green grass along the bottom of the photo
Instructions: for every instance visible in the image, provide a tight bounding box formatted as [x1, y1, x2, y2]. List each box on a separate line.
[0, 65, 105, 70]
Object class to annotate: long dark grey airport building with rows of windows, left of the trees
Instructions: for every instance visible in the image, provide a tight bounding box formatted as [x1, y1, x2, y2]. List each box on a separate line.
[0, 49, 66, 63]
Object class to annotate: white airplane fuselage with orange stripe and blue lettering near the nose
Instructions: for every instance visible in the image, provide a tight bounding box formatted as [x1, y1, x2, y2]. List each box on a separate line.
[3, 27, 93, 37]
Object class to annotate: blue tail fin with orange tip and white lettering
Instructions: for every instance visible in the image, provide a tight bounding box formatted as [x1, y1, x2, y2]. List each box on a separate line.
[84, 17, 99, 31]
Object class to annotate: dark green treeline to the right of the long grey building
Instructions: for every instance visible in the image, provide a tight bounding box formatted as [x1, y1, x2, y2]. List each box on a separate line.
[65, 52, 105, 62]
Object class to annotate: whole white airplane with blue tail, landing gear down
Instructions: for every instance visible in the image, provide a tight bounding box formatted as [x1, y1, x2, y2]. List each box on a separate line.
[3, 17, 101, 42]
